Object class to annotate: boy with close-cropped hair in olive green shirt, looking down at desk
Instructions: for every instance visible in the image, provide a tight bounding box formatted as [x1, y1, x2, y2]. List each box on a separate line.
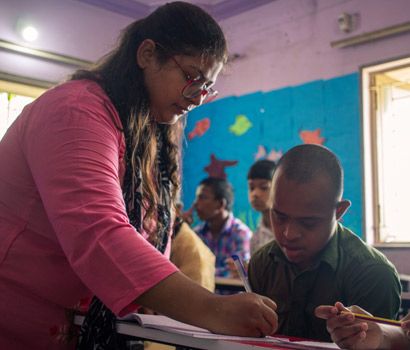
[248, 144, 401, 341]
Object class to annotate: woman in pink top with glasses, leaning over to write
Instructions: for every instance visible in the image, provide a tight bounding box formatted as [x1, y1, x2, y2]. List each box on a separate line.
[0, 2, 277, 350]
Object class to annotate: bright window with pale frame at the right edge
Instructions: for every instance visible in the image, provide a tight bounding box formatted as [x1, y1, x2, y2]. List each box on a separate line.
[361, 58, 410, 245]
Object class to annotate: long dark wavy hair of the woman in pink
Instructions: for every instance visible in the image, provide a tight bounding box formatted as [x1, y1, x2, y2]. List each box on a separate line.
[69, 1, 227, 240]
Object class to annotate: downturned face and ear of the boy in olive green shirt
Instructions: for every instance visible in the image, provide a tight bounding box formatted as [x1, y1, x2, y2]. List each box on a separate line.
[271, 169, 350, 270]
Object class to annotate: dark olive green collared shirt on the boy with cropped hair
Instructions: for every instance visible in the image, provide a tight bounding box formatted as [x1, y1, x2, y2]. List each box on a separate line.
[248, 223, 401, 341]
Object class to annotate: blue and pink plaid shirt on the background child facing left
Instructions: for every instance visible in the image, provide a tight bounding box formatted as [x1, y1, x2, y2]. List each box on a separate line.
[194, 213, 252, 277]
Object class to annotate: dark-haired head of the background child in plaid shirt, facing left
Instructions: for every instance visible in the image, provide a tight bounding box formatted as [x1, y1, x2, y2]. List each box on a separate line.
[194, 177, 234, 221]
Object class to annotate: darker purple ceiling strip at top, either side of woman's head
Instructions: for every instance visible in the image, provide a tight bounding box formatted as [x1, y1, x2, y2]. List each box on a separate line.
[78, 0, 274, 20]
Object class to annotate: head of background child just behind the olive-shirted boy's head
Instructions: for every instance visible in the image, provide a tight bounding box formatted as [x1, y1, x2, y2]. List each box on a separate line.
[247, 159, 276, 213]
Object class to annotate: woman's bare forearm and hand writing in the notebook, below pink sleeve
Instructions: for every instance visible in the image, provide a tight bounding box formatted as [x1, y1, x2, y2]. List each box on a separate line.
[135, 272, 278, 337]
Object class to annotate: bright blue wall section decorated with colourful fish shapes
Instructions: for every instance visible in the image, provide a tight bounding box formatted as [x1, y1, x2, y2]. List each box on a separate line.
[182, 73, 362, 236]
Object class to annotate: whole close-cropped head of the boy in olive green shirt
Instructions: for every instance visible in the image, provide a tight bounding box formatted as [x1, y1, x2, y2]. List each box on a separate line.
[270, 144, 350, 269]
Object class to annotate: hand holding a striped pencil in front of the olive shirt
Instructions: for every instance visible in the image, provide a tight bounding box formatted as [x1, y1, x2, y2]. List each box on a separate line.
[315, 302, 383, 349]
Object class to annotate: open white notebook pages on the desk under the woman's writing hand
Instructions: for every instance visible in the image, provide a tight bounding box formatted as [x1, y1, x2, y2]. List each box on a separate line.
[119, 313, 339, 350]
